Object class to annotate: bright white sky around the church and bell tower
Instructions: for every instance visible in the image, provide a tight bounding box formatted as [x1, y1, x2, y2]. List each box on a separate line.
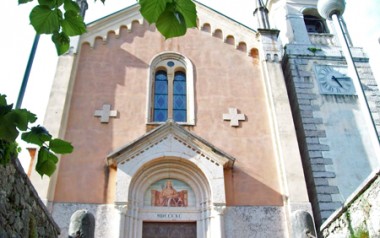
[0, 0, 380, 158]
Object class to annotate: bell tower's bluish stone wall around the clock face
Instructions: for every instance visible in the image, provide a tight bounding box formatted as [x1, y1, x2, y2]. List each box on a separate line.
[282, 44, 380, 229]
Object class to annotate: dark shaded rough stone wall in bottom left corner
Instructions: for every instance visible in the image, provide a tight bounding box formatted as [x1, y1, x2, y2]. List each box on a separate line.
[0, 160, 60, 238]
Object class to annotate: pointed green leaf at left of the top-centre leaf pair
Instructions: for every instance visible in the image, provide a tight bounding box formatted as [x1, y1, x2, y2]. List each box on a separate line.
[139, 0, 170, 24]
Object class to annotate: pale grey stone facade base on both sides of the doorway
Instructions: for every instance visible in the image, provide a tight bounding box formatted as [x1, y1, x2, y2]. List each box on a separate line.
[52, 203, 287, 238]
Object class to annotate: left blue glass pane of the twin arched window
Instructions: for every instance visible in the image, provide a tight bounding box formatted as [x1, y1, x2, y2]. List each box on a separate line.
[153, 70, 168, 121]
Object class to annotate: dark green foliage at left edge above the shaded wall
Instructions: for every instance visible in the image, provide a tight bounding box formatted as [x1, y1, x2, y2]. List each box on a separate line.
[0, 94, 73, 176]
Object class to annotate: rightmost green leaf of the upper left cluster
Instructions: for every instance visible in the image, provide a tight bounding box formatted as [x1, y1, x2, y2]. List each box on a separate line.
[61, 10, 86, 36]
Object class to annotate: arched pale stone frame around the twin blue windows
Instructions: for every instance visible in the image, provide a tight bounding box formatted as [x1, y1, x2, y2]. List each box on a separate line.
[146, 51, 195, 125]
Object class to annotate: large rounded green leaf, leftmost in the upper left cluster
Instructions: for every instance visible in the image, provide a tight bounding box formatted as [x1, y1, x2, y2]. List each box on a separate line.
[29, 5, 62, 34]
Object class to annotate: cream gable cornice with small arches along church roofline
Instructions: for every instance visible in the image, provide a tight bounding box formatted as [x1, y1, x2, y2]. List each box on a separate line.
[80, 1, 258, 54]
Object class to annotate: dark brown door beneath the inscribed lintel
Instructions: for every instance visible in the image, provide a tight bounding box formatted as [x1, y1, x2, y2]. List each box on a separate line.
[142, 222, 197, 238]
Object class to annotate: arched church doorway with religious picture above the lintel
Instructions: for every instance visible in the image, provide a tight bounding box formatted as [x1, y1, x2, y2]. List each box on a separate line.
[125, 157, 212, 237]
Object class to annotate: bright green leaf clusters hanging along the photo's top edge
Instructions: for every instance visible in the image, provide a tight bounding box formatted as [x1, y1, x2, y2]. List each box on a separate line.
[18, 0, 197, 55]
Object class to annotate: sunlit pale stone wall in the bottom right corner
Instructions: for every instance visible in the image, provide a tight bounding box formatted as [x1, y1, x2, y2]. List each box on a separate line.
[321, 170, 380, 238]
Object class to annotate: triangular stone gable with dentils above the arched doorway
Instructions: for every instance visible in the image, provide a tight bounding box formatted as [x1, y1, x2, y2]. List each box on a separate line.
[107, 121, 235, 168]
